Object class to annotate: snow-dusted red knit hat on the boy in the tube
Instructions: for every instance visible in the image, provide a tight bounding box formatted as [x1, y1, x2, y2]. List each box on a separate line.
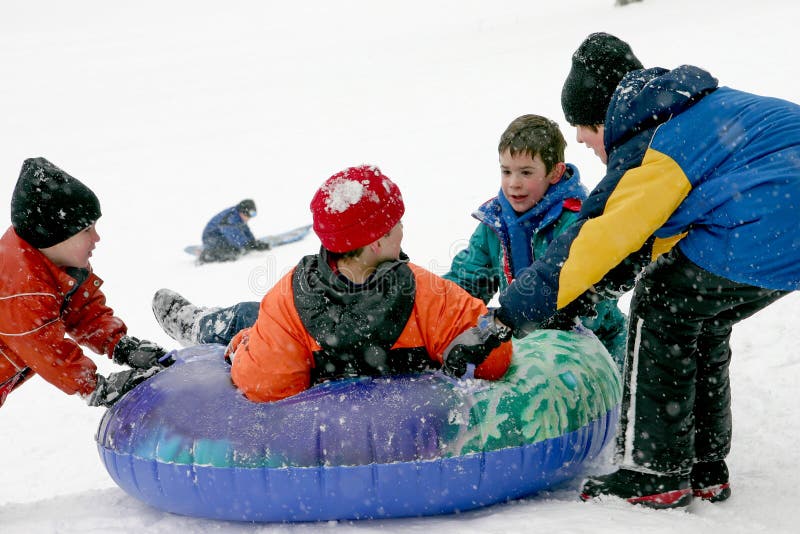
[311, 165, 406, 253]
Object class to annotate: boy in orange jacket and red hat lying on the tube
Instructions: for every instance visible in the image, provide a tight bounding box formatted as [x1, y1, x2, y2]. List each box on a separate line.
[153, 166, 511, 402]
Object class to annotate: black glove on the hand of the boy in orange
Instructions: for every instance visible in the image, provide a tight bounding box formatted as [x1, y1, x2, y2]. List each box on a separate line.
[442, 310, 511, 378]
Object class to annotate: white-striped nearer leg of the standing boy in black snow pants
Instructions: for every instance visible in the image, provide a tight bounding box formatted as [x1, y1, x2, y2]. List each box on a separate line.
[615, 254, 702, 478]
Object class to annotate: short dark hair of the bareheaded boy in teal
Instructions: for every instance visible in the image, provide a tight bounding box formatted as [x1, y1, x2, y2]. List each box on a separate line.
[497, 115, 567, 172]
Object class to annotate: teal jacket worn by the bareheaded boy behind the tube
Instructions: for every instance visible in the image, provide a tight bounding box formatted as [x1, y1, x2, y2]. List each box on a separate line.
[444, 164, 626, 364]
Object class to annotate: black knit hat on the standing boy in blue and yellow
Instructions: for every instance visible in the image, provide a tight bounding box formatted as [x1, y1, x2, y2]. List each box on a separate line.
[561, 32, 643, 126]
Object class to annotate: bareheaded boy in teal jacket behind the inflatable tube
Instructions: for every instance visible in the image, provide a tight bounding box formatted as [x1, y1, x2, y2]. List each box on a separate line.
[444, 115, 626, 368]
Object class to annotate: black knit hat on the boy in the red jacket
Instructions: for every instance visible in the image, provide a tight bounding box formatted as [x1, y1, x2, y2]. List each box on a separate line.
[11, 158, 101, 248]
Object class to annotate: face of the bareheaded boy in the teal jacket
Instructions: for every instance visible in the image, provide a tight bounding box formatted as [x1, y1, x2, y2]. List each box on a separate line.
[500, 150, 564, 213]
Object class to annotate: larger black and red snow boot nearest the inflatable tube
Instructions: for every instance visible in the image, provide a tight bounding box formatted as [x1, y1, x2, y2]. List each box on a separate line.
[581, 469, 692, 509]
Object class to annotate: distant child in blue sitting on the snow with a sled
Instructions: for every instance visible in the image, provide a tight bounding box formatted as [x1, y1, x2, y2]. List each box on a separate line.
[198, 198, 269, 263]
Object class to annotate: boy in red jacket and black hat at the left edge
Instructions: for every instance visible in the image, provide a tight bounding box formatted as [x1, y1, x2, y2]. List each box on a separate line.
[0, 158, 169, 406]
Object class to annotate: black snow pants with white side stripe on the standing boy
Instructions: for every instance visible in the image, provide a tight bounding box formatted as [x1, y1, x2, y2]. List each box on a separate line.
[615, 247, 788, 475]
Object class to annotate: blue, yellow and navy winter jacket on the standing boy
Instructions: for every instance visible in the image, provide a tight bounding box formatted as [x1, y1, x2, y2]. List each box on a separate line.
[498, 65, 800, 333]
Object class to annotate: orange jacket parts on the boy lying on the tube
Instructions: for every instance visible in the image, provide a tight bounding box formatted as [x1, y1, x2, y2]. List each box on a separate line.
[231, 263, 511, 402]
